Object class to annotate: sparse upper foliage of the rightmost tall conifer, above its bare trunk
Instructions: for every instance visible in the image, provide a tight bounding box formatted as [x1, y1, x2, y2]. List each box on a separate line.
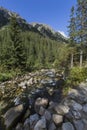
[76, 0, 87, 48]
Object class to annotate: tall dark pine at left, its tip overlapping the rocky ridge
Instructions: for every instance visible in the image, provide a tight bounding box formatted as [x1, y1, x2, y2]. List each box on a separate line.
[9, 15, 26, 68]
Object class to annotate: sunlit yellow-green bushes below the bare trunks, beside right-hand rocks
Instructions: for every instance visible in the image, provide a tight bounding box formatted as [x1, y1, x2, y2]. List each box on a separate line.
[62, 67, 87, 96]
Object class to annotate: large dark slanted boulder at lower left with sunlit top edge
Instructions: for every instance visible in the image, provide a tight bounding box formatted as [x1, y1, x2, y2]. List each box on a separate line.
[3, 104, 24, 129]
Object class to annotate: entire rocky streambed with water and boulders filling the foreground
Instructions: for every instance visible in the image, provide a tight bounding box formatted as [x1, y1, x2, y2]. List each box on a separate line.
[0, 70, 87, 130]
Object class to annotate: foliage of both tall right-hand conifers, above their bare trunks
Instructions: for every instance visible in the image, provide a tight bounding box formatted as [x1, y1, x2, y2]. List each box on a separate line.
[68, 0, 87, 51]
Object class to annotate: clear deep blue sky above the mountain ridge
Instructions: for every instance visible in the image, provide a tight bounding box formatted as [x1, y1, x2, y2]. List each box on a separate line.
[0, 0, 76, 34]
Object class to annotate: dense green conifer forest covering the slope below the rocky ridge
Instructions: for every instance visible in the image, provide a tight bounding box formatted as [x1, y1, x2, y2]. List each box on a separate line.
[0, 16, 69, 75]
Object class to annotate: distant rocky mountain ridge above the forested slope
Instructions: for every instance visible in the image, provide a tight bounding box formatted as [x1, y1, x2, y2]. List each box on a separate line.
[0, 7, 67, 42]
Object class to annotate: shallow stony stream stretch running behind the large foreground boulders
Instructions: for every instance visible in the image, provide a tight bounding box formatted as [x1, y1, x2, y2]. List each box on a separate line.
[0, 69, 63, 129]
